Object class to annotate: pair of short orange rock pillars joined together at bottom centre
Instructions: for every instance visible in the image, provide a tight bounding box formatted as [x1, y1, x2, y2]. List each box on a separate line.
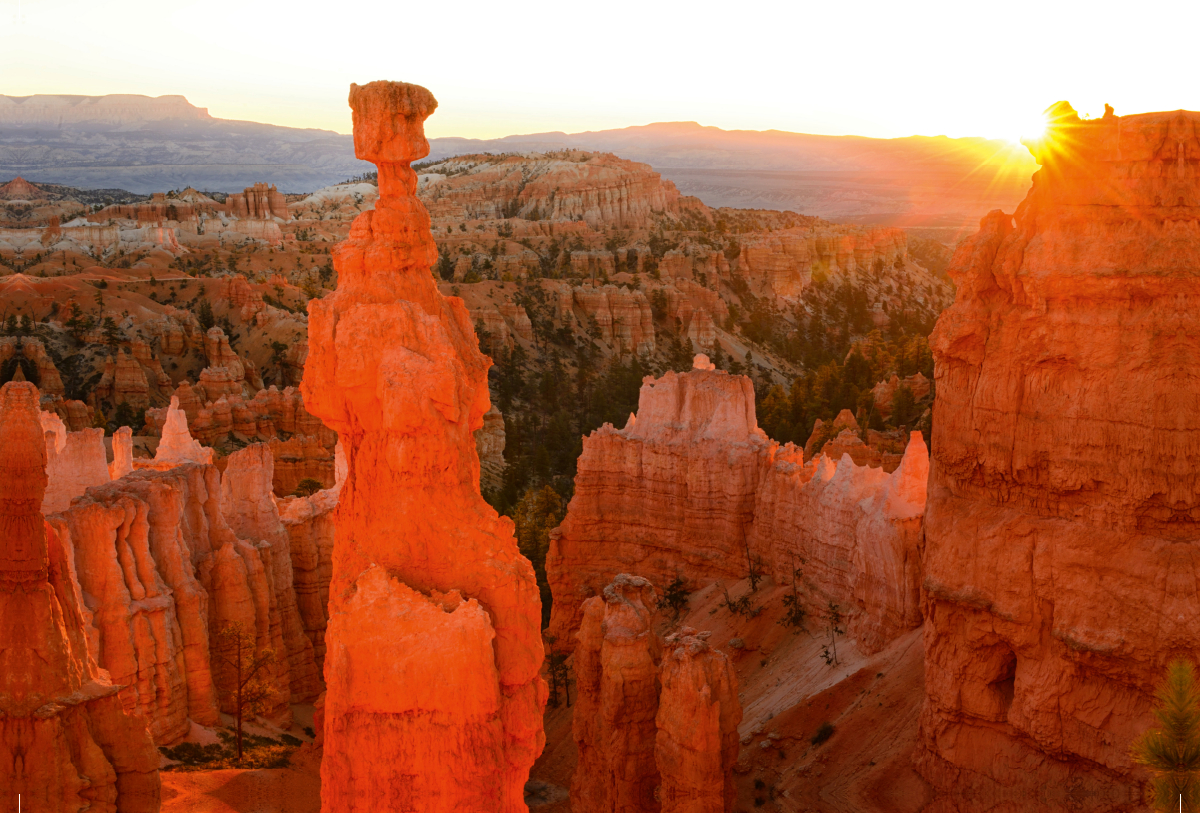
[571, 573, 742, 813]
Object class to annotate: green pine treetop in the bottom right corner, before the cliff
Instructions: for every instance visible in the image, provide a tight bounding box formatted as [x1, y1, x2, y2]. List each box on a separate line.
[1133, 661, 1200, 813]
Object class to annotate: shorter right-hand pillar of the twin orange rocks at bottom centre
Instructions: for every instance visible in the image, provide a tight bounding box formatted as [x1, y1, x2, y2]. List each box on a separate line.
[654, 627, 742, 813]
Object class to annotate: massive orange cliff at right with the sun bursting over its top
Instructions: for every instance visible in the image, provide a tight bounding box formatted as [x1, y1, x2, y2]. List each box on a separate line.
[919, 103, 1200, 811]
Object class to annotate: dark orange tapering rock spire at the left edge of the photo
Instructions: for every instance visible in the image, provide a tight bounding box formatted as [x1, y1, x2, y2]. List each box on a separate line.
[0, 383, 160, 813]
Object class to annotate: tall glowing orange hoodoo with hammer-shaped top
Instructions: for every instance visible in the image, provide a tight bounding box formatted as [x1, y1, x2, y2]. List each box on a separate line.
[301, 82, 547, 813]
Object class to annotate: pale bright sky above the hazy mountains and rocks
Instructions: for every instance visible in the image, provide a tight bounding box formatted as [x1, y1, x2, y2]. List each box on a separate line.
[0, 0, 1200, 139]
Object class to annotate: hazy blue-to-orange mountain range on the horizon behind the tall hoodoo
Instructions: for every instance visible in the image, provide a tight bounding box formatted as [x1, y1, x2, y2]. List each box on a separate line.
[0, 96, 1036, 225]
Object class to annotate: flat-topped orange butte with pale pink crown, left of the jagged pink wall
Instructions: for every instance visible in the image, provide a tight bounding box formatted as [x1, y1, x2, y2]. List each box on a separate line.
[546, 356, 774, 645]
